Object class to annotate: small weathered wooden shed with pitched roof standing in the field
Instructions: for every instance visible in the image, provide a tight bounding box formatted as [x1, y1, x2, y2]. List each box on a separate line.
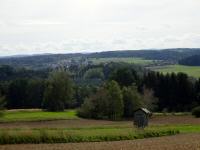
[134, 108, 152, 128]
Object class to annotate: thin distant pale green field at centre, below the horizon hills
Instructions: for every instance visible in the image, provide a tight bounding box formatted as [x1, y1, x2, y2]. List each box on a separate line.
[90, 57, 153, 65]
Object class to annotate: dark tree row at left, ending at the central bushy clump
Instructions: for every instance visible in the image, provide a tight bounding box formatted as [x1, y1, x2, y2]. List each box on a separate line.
[0, 71, 96, 111]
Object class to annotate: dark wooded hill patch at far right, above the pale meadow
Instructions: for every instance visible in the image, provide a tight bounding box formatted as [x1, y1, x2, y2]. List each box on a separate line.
[179, 55, 200, 66]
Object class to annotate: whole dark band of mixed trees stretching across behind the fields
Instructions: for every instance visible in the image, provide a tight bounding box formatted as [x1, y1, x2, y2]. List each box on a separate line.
[0, 63, 200, 120]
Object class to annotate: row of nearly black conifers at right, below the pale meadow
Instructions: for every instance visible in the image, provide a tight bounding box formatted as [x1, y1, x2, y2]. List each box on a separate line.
[143, 72, 200, 112]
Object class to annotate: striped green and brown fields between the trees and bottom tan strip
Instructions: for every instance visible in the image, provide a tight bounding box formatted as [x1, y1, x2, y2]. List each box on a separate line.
[0, 110, 200, 144]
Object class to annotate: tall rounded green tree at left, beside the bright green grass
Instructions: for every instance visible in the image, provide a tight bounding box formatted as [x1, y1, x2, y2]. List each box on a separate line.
[43, 71, 73, 111]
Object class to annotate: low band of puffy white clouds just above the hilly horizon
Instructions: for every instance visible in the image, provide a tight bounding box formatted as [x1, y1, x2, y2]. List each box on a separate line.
[0, 34, 200, 55]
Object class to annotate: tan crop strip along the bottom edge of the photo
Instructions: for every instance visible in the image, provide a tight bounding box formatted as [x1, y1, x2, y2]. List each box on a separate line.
[0, 134, 200, 150]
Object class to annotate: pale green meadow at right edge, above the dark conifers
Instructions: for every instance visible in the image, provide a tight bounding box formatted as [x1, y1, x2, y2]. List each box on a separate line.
[155, 65, 200, 78]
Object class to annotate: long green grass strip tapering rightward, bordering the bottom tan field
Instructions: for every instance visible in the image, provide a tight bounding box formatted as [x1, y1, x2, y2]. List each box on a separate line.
[0, 128, 179, 144]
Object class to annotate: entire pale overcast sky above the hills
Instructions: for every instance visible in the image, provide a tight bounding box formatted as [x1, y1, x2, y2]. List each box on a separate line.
[0, 0, 200, 56]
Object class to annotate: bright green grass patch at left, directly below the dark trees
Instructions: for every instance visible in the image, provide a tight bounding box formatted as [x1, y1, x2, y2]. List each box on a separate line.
[0, 110, 78, 122]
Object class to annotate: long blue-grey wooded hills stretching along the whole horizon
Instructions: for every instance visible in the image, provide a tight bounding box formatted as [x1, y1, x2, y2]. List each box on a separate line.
[0, 48, 200, 69]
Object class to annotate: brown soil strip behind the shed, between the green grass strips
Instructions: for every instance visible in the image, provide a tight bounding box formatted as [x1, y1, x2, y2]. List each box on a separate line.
[0, 115, 200, 128]
